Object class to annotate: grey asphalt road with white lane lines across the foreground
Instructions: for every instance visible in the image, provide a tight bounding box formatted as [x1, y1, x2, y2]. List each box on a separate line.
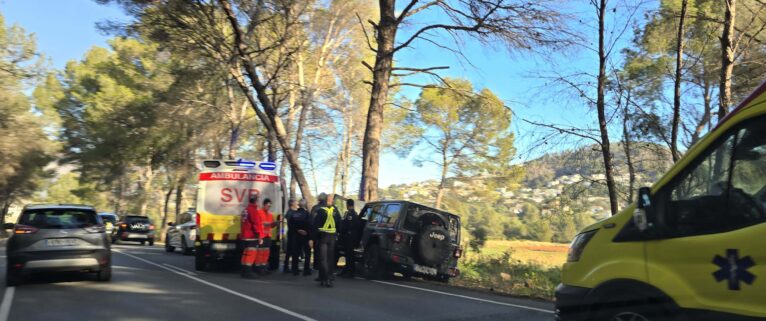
[0, 245, 553, 321]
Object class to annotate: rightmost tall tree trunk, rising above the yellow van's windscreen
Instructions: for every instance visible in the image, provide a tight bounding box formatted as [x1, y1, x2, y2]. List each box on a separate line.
[718, 0, 737, 121]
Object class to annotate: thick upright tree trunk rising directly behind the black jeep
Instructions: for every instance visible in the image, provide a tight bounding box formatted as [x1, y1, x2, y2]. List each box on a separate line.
[359, 0, 397, 202]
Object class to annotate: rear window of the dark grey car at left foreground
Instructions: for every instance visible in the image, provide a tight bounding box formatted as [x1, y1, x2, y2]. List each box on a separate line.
[19, 209, 97, 229]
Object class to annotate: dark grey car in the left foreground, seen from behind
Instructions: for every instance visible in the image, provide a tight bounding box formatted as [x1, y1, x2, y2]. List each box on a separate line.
[6, 204, 112, 286]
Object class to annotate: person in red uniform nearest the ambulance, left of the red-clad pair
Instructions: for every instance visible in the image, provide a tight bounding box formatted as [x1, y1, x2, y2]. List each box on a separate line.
[240, 196, 263, 279]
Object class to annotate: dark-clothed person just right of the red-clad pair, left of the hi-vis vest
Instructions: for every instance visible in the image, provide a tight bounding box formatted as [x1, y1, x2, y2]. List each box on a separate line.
[285, 198, 311, 275]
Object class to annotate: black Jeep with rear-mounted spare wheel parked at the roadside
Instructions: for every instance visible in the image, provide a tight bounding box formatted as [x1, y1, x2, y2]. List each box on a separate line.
[357, 201, 462, 282]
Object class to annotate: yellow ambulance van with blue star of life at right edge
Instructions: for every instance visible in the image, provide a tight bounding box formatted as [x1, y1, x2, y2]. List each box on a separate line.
[556, 83, 766, 321]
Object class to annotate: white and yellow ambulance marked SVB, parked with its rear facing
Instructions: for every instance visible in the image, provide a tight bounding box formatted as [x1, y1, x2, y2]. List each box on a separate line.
[194, 160, 285, 270]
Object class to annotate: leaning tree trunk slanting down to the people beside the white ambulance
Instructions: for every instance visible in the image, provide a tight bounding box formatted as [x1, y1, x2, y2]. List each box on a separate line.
[219, 0, 314, 203]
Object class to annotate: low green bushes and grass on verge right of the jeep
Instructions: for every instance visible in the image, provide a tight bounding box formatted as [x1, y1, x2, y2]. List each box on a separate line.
[453, 251, 561, 300]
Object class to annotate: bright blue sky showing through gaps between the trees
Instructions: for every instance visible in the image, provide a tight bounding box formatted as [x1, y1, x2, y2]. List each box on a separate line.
[0, 0, 648, 189]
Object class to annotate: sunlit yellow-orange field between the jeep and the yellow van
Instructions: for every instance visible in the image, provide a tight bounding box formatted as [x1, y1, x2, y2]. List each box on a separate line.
[474, 240, 569, 268]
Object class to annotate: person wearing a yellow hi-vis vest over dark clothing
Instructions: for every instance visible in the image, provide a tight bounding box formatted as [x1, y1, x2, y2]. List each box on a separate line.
[312, 194, 341, 288]
